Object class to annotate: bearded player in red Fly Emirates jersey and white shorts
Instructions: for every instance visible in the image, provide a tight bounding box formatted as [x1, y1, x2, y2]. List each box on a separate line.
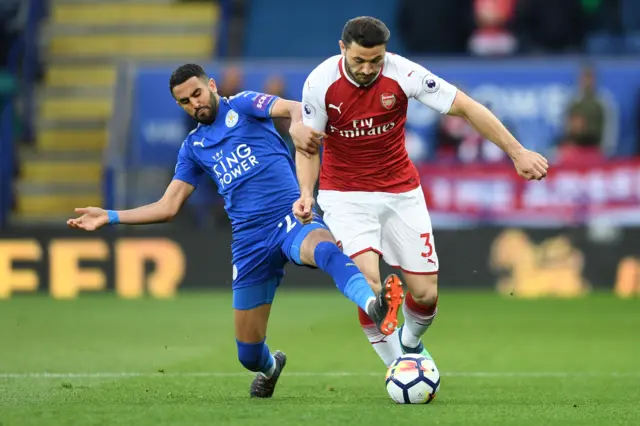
[292, 17, 548, 365]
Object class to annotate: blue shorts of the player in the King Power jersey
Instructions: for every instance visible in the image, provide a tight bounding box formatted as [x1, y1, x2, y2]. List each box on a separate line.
[232, 213, 328, 310]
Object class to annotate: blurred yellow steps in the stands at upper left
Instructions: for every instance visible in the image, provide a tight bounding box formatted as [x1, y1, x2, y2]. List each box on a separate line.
[15, 0, 219, 225]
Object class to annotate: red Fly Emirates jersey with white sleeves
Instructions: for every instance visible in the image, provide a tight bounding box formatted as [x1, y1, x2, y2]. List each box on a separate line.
[302, 53, 456, 193]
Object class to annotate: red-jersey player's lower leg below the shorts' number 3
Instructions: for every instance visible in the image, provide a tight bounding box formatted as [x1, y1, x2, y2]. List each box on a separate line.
[400, 273, 438, 358]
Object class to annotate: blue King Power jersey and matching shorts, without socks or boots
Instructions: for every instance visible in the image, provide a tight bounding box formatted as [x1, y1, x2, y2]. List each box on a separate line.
[174, 92, 326, 309]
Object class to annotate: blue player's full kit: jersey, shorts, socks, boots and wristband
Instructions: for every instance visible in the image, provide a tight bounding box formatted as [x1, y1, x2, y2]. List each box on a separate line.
[99, 87, 403, 398]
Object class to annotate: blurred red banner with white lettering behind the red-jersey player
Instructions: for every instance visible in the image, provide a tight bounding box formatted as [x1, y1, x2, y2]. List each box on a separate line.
[419, 159, 640, 226]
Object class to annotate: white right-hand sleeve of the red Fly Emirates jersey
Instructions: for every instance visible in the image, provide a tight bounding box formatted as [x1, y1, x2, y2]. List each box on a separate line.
[397, 57, 458, 114]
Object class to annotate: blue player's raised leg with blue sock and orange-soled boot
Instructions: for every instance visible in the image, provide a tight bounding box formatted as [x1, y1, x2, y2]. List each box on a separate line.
[299, 228, 404, 335]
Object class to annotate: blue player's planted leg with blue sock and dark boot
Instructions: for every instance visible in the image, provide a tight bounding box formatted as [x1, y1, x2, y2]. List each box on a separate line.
[233, 280, 287, 398]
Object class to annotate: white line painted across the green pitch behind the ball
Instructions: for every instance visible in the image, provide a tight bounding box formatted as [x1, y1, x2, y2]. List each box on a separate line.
[0, 370, 640, 379]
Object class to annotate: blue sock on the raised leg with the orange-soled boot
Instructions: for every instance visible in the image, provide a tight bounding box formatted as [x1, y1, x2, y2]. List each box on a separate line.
[313, 241, 376, 312]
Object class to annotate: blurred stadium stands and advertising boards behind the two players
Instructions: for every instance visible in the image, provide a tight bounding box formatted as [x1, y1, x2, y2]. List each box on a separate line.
[0, 0, 640, 297]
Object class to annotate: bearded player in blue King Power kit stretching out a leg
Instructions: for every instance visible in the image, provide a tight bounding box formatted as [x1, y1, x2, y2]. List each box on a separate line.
[67, 64, 403, 398]
